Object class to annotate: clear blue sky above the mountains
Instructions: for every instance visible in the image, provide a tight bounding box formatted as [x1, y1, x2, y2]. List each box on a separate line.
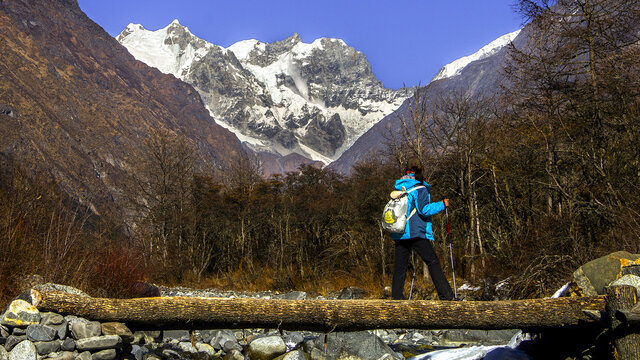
[78, 0, 522, 89]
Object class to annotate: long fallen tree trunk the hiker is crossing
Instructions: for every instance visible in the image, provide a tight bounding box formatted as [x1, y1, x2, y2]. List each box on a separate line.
[31, 290, 605, 331]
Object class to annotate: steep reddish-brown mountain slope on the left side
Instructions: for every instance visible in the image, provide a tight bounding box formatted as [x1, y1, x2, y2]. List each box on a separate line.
[0, 0, 243, 213]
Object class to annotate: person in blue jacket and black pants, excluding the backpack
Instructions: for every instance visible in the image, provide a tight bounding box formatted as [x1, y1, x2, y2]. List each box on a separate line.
[391, 158, 454, 300]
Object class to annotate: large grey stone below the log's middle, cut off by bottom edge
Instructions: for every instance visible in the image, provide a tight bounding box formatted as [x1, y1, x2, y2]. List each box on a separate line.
[311, 331, 398, 359]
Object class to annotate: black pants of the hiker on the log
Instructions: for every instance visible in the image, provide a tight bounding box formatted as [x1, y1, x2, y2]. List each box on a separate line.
[391, 238, 453, 300]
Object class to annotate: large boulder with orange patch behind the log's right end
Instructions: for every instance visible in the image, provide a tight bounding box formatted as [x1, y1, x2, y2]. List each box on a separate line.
[573, 251, 640, 296]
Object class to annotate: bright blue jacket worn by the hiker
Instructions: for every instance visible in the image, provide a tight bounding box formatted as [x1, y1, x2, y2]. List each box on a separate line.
[391, 178, 444, 241]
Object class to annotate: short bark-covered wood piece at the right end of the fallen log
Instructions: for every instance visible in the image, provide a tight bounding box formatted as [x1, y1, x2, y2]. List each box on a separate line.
[606, 285, 640, 360]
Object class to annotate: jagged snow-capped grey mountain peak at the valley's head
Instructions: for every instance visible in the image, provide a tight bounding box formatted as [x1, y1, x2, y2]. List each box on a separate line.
[117, 20, 409, 163]
